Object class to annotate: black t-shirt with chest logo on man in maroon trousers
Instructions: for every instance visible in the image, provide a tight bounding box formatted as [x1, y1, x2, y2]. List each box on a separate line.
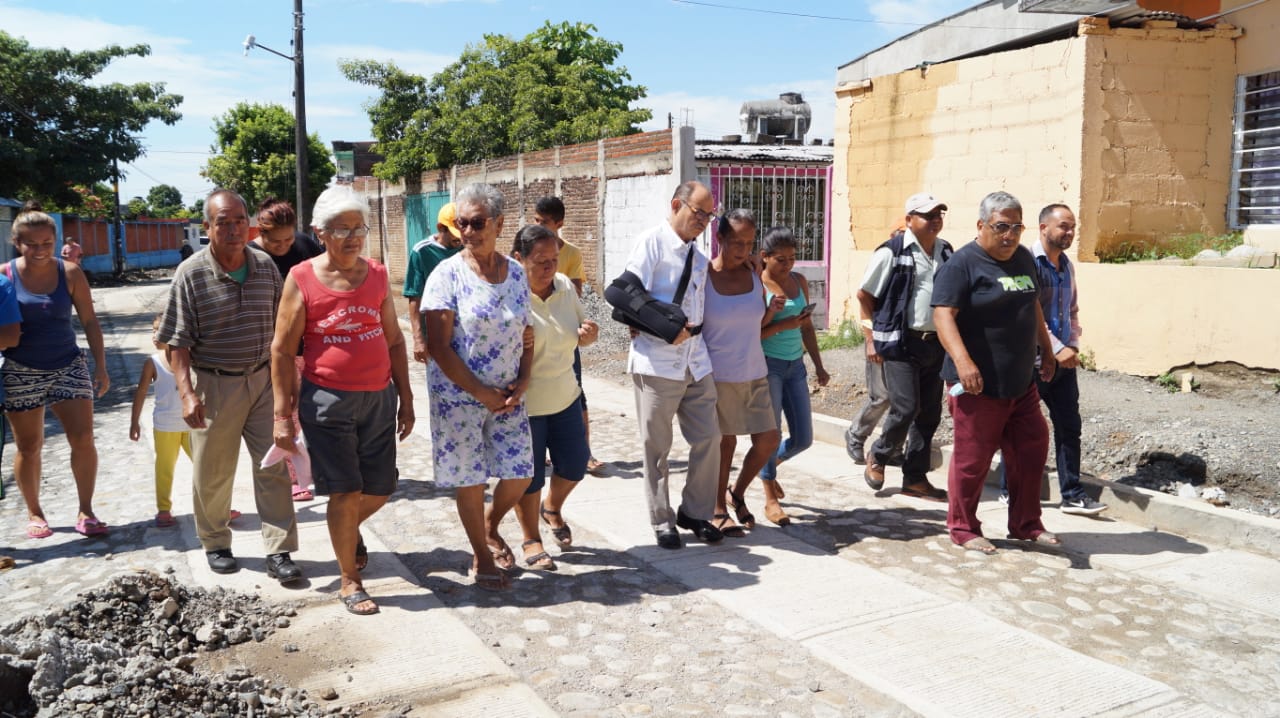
[933, 242, 1039, 399]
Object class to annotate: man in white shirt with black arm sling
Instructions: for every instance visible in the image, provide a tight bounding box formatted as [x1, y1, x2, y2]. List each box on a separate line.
[626, 182, 723, 549]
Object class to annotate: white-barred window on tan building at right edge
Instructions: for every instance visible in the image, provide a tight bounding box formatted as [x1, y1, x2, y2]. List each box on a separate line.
[1229, 70, 1280, 229]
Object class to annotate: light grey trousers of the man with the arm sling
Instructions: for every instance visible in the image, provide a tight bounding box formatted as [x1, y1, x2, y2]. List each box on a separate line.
[631, 371, 721, 531]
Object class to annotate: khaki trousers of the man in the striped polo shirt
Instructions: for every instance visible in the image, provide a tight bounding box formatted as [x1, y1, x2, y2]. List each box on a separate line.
[191, 367, 298, 554]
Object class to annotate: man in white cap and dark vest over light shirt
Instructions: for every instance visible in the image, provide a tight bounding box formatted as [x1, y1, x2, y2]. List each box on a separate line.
[858, 192, 952, 502]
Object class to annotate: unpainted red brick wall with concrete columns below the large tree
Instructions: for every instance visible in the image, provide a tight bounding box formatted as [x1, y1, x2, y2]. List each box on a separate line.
[356, 131, 676, 287]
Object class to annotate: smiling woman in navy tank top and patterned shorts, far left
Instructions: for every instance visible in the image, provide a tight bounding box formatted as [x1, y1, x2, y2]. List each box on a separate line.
[0, 212, 110, 539]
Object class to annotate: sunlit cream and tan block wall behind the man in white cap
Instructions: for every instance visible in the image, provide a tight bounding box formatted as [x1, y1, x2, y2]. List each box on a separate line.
[831, 38, 1085, 323]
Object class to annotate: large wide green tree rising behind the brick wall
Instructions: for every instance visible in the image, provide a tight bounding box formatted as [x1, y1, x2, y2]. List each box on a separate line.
[339, 22, 653, 179]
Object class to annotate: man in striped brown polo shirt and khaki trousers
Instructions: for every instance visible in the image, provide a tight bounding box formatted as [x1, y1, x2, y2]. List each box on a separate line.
[156, 189, 302, 584]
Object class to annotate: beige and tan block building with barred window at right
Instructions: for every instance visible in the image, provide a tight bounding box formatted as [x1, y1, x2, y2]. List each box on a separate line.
[829, 0, 1280, 375]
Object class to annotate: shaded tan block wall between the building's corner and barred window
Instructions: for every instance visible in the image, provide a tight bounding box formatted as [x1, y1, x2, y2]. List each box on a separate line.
[1078, 22, 1238, 260]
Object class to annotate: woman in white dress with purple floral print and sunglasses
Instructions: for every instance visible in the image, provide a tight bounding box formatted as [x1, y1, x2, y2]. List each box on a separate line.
[421, 183, 534, 591]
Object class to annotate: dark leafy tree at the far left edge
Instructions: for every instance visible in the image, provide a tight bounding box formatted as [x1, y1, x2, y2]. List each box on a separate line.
[0, 31, 182, 206]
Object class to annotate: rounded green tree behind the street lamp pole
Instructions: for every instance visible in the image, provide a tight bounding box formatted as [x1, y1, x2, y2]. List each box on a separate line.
[201, 102, 337, 211]
